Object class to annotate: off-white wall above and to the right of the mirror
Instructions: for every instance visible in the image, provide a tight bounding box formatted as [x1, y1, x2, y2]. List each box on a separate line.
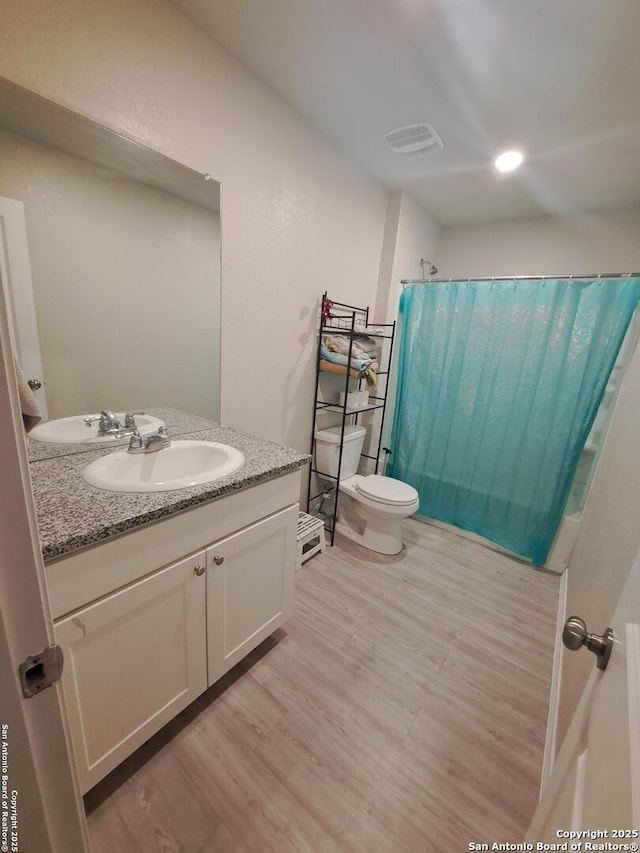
[0, 0, 387, 448]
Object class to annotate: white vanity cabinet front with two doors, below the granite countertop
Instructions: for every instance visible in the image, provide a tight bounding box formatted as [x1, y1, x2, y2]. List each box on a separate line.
[46, 470, 300, 793]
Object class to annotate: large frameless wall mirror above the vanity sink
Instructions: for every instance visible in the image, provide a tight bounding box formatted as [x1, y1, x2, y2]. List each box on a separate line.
[0, 79, 221, 456]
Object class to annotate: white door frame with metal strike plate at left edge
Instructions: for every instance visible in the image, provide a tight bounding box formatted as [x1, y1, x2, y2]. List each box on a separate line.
[0, 251, 89, 853]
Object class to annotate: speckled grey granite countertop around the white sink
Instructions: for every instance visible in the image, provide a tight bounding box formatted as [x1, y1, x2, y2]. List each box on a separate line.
[29, 410, 310, 562]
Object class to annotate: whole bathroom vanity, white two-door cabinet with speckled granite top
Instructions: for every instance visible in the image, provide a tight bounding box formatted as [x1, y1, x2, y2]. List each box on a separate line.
[31, 410, 308, 792]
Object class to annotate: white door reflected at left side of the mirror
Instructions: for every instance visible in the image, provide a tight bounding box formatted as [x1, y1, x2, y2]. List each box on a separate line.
[0, 196, 47, 418]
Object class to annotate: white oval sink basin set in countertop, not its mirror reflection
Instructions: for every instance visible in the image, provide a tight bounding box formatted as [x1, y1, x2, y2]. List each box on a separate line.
[82, 441, 244, 492]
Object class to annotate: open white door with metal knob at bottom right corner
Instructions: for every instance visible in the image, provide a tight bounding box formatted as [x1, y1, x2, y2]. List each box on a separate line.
[527, 553, 640, 850]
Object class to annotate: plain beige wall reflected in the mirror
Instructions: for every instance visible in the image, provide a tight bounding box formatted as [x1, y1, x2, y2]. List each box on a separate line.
[0, 126, 220, 420]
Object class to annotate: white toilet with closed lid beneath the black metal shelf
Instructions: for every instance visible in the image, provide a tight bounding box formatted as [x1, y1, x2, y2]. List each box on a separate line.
[315, 426, 420, 554]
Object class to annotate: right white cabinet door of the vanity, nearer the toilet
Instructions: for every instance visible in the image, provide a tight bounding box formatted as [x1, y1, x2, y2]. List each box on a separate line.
[207, 504, 298, 684]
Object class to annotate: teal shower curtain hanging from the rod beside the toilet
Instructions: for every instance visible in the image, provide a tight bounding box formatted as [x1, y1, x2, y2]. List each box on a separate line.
[387, 277, 640, 565]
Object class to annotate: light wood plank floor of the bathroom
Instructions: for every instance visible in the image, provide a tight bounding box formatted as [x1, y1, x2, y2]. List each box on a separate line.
[86, 521, 558, 853]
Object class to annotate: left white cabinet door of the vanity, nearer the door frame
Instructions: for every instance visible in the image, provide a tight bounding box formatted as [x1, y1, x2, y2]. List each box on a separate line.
[55, 551, 207, 793]
